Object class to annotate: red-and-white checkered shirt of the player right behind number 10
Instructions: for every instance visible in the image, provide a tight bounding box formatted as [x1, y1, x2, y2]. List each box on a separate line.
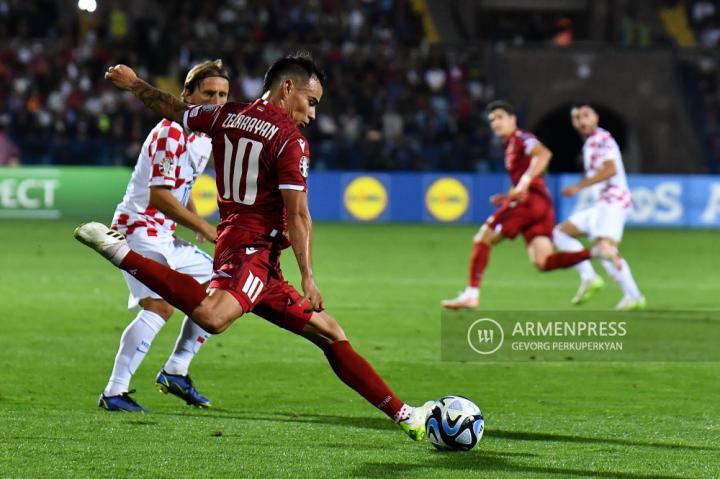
[112, 120, 212, 237]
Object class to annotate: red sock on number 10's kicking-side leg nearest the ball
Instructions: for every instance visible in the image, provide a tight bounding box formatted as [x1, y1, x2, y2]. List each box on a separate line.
[325, 341, 403, 418]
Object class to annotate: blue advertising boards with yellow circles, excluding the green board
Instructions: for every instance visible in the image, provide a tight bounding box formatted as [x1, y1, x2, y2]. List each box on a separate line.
[187, 171, 720, 228]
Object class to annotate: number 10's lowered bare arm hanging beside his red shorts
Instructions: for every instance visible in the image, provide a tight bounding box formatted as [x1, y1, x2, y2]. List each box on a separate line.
[280, 189, 325, 311]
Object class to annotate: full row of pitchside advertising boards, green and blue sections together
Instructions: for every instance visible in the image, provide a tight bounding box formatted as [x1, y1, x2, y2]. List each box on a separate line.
[0, 167, 720, 228]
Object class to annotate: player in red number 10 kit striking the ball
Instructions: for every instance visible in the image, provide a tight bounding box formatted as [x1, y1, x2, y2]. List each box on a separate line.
[75, 54, 434, 440]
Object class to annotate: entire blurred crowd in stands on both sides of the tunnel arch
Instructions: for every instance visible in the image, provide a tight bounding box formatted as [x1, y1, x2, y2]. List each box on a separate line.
[0, 0, 720, 172]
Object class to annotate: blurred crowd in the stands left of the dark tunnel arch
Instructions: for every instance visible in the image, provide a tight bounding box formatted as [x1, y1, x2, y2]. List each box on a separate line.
[0, 0, 500, 170]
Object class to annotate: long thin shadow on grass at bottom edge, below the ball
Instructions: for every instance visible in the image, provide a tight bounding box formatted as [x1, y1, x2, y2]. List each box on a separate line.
[353, 456, 683, 479]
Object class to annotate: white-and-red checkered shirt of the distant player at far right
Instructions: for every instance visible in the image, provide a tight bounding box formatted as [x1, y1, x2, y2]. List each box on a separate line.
[583, 128, 632, 209]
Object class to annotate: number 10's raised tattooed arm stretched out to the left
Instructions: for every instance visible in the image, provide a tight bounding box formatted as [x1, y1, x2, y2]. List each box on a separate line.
[105, 65, 188, 125]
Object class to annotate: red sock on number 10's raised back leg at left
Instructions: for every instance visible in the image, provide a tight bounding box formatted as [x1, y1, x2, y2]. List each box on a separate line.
[120, 250, 207, 316]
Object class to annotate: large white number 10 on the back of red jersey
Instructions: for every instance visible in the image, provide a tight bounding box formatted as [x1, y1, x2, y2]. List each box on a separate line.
[222, 135, 262, 205]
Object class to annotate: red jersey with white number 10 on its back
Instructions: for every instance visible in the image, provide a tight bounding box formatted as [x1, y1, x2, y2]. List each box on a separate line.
[183, 100, 310, 236]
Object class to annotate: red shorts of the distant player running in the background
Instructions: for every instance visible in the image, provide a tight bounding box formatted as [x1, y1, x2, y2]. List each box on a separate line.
[485, 191, 555, 243]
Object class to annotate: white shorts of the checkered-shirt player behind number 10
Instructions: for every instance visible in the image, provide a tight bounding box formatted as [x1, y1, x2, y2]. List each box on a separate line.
[123, 235, 213, 310]
